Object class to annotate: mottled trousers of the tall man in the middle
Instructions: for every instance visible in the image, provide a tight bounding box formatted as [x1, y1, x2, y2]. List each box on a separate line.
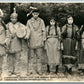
[28, 48, 43, 73]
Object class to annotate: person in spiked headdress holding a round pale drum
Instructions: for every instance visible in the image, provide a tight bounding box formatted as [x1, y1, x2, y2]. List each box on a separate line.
[6, 8, 26, 76]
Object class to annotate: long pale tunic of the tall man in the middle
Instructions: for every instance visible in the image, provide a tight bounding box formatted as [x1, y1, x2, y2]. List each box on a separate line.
[27, 17, 46, 48]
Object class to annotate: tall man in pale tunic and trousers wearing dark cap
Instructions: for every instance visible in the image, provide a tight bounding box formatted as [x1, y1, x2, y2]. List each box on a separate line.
[27, 9, 46, 74]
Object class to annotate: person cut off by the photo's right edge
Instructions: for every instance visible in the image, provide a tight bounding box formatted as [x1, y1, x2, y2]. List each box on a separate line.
[78, 25, 84, 75]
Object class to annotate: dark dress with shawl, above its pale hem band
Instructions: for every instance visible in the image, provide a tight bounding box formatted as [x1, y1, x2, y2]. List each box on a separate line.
[62, 24, 78, 55]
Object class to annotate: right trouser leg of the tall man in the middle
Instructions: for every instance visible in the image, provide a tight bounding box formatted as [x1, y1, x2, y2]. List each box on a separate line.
[36, 48, 43, 74]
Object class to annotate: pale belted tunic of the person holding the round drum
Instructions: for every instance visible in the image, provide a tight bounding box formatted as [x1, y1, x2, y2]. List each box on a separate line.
[7, 22, 25, 53]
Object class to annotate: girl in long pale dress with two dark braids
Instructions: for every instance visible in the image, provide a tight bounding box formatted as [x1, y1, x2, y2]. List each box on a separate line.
[45, 18, 61, 73]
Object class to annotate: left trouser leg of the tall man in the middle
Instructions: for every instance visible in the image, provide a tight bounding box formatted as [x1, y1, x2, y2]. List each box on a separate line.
[28, 49, 36, 74]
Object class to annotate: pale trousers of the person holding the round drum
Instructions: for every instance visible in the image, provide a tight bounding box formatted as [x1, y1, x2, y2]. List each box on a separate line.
[7, 52, 21, 73]
